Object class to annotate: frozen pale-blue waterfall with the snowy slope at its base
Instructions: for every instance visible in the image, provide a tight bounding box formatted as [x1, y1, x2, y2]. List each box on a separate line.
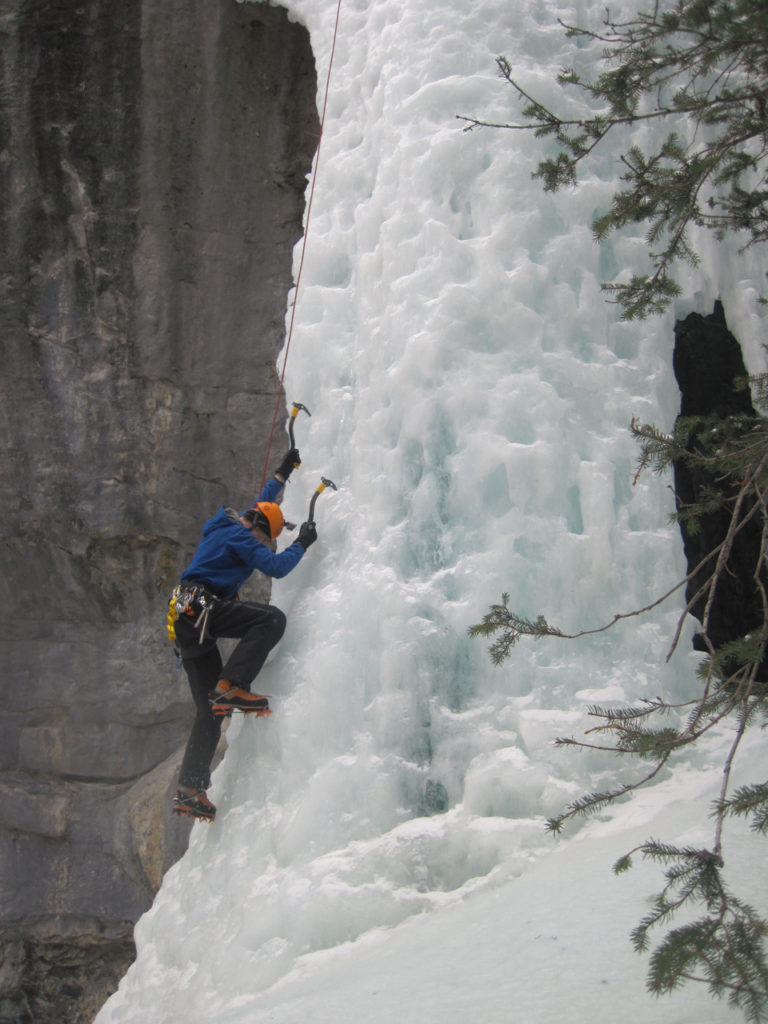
[97, 0, 768, 1024]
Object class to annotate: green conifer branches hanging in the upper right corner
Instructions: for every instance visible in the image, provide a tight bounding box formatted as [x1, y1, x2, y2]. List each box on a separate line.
[462, 0, 768, 319]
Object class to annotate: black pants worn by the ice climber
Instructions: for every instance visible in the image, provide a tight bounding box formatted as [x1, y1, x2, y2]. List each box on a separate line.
[176, 601, 286, 790]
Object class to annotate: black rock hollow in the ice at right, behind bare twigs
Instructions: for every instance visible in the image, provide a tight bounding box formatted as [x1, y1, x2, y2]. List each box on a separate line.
[674, 302, 768, 678]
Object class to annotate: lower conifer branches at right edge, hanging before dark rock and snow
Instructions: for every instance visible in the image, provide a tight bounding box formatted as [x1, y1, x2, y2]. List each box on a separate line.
[469, 389, 768, 1022]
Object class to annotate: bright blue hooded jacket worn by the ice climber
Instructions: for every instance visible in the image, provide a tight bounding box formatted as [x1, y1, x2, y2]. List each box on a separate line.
[181, 477, 304, 599]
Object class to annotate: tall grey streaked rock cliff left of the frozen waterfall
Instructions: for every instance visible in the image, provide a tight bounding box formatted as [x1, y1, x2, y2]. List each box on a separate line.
[0, 0, 318, 1024]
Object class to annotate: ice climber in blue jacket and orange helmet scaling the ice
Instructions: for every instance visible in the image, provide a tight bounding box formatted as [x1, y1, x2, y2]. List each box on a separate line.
[169, 449, 317, 821]
